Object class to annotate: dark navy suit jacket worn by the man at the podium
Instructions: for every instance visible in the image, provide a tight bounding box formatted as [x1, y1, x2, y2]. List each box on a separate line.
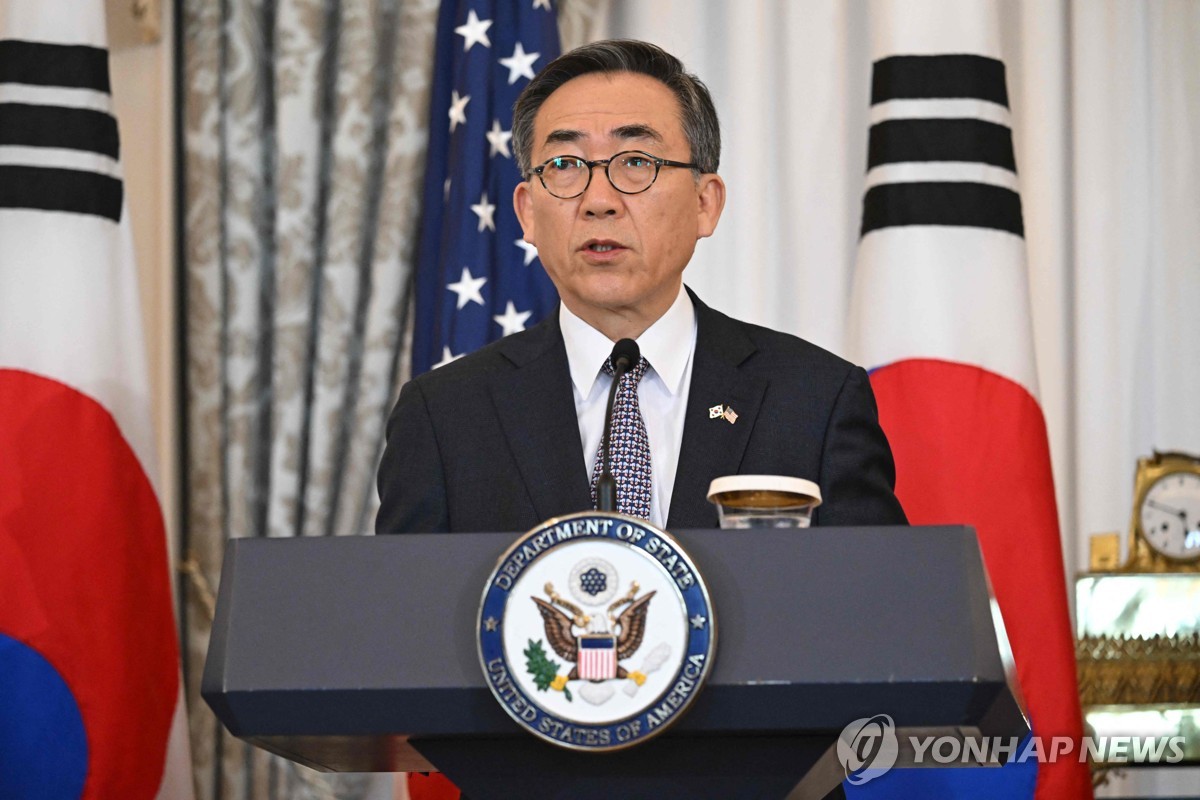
[376, 290, 906, 534]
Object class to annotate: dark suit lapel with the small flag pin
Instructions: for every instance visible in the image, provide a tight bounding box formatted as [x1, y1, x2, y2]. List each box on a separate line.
[667, 289, 767, 530]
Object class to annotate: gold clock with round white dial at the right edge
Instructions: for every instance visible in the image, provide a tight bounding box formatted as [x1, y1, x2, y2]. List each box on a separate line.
[1127, 452, 1200, 572]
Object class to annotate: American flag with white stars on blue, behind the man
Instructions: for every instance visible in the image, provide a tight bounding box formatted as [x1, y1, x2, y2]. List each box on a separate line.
[413, 0, 559, 375]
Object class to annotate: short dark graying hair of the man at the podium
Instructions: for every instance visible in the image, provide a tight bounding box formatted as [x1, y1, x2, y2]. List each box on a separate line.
[512, 38, 721, 175]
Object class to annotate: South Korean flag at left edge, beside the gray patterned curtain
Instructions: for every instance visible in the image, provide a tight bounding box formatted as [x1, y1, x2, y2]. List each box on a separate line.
[0, 0, 192, 800]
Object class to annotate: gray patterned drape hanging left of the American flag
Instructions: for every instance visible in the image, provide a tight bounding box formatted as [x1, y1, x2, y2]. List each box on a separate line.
[181, 0, 437, 800]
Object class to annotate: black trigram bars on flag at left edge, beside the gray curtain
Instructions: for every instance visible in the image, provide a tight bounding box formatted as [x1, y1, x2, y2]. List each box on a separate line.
[0, 40, 124, 222]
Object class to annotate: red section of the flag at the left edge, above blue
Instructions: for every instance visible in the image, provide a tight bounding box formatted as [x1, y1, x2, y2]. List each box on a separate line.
[0, 369, 179, 799]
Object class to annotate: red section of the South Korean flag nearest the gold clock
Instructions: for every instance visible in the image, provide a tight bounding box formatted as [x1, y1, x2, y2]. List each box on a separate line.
[871, 360, 1091, 800]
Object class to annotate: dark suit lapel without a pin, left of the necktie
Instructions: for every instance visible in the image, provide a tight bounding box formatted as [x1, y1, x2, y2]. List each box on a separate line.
[492, 309, 592, 522]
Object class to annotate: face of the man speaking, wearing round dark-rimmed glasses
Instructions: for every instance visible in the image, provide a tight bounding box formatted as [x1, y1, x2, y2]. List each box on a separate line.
[514, 72, 725, 337]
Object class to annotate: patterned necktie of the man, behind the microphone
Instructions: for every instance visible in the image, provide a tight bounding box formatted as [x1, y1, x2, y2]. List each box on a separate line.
[592, 357, 650, 519]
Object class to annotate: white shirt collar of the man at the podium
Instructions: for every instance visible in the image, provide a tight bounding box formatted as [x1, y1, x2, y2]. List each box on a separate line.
[558, 285, 696, 397]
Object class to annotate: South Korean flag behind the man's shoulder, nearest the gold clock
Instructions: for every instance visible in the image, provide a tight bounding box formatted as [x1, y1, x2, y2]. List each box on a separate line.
[847, 0, 1091, 800]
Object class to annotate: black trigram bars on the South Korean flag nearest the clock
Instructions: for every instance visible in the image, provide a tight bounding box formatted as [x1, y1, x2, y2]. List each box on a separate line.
[862, 55, 1025, 236]
